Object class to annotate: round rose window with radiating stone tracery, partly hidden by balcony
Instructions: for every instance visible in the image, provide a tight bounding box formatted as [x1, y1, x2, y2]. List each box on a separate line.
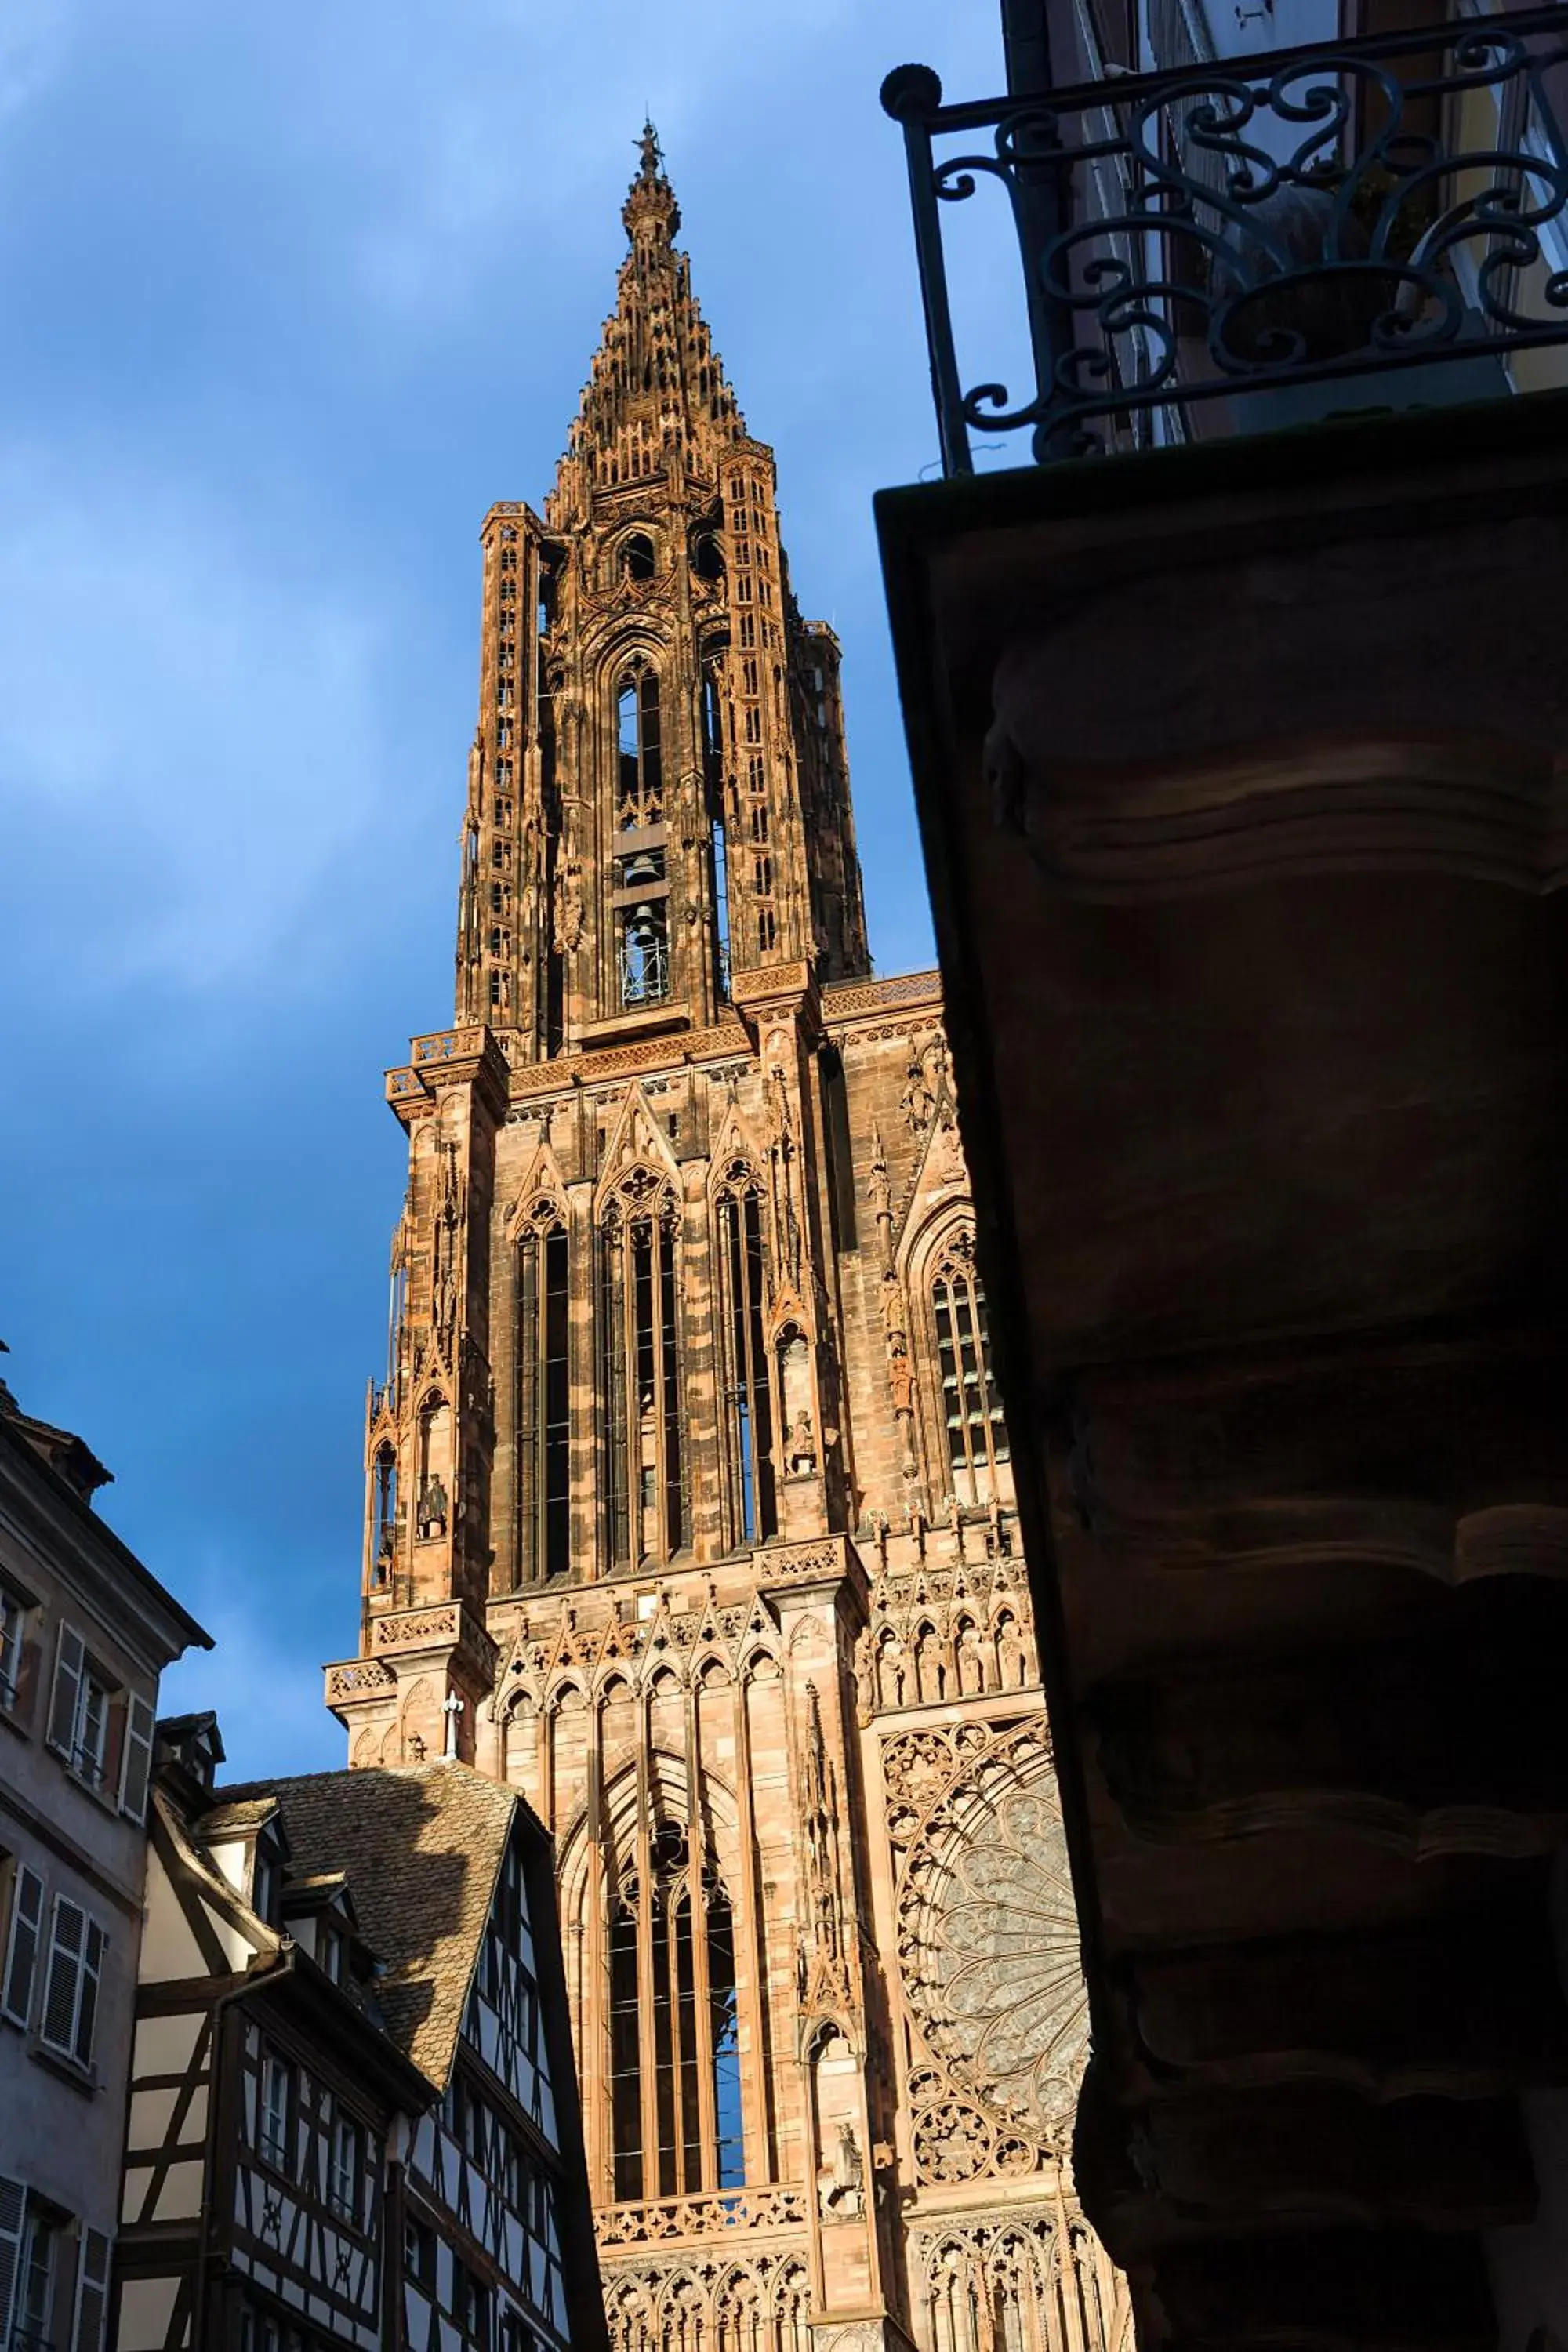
[900, 1731, 1088, 2159]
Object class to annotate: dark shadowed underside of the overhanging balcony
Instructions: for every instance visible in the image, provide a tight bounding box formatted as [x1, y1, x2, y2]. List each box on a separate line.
[881, 395, 1568, 2352]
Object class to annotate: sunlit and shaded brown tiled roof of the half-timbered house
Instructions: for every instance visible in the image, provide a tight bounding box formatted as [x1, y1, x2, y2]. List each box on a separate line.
[215, 1764, 517, 2089]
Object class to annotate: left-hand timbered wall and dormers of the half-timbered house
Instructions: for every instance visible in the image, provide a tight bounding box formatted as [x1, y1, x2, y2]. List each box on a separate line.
[113, 1715, 433, 2352]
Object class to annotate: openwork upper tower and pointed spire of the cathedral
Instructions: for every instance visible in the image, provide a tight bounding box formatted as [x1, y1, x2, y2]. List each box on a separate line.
[456, 122, 867, 1040]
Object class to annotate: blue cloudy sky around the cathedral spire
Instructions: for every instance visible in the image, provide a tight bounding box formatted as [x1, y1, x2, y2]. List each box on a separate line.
[0, 0, 1001, 1773]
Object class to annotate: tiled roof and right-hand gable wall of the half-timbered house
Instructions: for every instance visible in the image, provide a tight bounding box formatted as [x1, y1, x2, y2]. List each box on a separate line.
[241, 1759, 604, 2352]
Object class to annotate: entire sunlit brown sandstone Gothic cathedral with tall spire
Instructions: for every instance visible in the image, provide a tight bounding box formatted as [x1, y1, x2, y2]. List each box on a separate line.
[327, 129, 1128, 2352]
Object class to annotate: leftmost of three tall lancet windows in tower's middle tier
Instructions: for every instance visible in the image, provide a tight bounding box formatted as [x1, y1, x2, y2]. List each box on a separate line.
[517, 1200, 572, 1583]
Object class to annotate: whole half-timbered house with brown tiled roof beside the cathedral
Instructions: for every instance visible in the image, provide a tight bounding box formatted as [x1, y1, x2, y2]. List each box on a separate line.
[113, 1715, 604, 2352]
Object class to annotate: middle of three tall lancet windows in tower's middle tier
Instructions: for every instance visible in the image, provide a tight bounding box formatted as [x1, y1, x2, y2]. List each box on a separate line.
[600, 1169, 687, 1566]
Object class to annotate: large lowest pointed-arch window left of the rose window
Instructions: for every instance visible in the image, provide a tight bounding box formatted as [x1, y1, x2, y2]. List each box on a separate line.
[609, 1828, 746, 2204]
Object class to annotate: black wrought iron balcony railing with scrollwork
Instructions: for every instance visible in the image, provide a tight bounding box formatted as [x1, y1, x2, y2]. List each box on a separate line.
[881, 5, 1568, 475]
